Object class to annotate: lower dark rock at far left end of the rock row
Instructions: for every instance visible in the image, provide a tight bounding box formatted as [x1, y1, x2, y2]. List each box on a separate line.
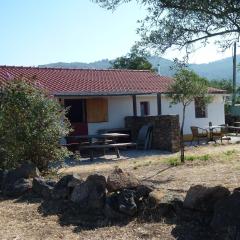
[3, 178, 32, 197]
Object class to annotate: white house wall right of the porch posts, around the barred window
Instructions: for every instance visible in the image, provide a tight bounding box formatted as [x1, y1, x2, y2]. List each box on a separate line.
[162, 95, 225, 134]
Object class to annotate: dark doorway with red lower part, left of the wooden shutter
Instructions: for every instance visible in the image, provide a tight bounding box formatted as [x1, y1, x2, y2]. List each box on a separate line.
[64, 99, 88, 135]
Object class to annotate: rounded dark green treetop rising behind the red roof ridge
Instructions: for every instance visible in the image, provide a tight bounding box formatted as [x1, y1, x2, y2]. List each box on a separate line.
[112, 52, 153, 70]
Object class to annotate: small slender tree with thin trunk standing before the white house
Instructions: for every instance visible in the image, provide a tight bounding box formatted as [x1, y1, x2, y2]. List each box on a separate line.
[168, 67, 211, 162]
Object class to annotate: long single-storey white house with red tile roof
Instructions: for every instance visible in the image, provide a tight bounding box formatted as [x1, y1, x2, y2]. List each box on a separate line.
[0, 66, 225, 137]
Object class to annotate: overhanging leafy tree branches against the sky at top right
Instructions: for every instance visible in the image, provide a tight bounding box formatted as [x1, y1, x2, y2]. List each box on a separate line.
[92, 0, 240, 53]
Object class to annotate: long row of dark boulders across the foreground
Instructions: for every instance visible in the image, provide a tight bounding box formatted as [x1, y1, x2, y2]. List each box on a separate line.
[0, 164, 240, 236]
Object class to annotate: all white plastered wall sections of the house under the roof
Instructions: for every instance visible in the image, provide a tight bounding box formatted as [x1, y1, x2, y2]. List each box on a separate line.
[61, 94, 225, 134]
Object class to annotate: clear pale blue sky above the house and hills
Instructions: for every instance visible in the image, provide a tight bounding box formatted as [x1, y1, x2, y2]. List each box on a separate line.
[0, 0, 238, 66]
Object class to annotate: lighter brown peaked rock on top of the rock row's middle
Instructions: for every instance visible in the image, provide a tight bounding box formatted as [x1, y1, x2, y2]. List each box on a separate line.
[107, 168, 140, 192]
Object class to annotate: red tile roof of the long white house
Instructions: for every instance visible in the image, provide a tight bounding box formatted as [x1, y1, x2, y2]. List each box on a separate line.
[0, 66, 225, 95]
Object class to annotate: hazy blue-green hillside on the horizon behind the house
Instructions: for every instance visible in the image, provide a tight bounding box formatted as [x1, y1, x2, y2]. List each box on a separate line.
[39, 55, 240, 83]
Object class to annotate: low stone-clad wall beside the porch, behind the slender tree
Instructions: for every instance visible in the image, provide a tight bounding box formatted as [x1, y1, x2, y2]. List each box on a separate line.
[125, 115, 180, 152]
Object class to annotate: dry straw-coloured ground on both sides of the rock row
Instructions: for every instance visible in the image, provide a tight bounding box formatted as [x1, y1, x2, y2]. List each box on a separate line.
[0, 144, 240, 240]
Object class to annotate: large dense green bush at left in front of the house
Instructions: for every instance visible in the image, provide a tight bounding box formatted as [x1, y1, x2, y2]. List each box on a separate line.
[0, 79, 70, 170]
